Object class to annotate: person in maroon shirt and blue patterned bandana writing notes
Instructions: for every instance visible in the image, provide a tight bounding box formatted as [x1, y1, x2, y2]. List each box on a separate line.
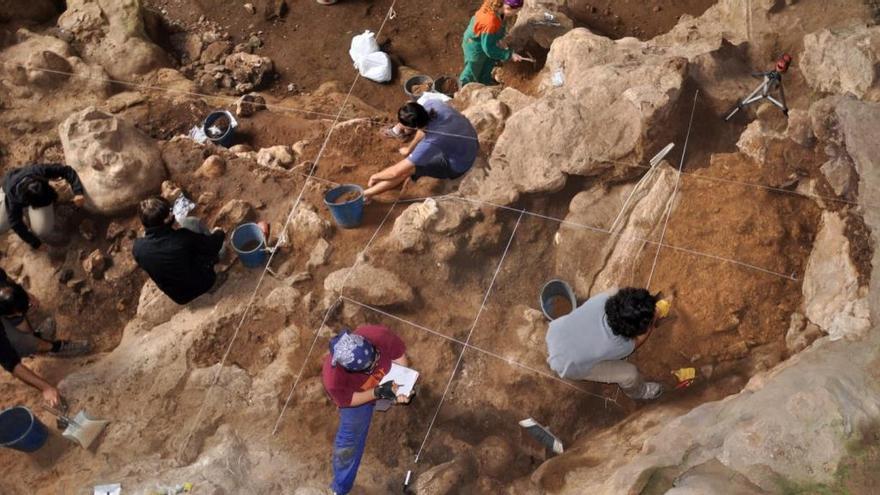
[321, 325, 409, 495]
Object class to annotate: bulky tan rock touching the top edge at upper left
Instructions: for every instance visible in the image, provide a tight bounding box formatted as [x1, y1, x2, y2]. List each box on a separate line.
[58, 0, 170, 80]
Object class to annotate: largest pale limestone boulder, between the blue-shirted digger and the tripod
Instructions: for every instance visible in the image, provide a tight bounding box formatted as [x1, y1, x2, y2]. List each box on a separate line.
[470, 29, 688, 203]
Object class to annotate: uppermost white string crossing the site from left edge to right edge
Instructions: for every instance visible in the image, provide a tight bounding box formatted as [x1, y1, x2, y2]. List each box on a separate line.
[6, 62, 880, 208]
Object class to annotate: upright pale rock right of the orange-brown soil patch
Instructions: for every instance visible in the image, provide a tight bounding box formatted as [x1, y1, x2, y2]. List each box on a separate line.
[803, 211, 871, 340]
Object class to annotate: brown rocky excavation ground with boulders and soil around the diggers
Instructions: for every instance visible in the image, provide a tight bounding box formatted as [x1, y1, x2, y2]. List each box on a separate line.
[0, 0, 880, 495]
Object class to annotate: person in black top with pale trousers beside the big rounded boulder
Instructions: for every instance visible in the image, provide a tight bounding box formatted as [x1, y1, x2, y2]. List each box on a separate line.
[0, 164, 86, 249]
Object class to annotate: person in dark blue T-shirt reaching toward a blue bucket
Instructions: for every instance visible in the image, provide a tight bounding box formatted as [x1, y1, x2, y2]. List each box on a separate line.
[364, 100, 480, 199]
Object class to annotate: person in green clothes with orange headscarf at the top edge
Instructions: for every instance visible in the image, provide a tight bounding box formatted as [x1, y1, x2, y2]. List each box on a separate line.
[459, 0, 523, 85]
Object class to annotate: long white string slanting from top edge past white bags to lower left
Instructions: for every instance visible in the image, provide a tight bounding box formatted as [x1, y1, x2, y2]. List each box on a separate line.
[178, 0, 397, 458]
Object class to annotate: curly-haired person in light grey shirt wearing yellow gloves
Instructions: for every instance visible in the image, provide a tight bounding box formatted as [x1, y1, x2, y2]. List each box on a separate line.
[547, 288, 665, 399]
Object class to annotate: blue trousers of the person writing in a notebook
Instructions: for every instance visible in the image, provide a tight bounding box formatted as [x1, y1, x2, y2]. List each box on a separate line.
[330, 402, 375, 495]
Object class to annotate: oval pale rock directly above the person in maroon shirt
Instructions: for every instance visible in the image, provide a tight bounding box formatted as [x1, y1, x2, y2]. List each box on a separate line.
[324, 263, 415, 306]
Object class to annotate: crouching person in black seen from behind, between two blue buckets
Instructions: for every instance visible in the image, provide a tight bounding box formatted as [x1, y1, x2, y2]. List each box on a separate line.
[133, 197, 226, 304]
